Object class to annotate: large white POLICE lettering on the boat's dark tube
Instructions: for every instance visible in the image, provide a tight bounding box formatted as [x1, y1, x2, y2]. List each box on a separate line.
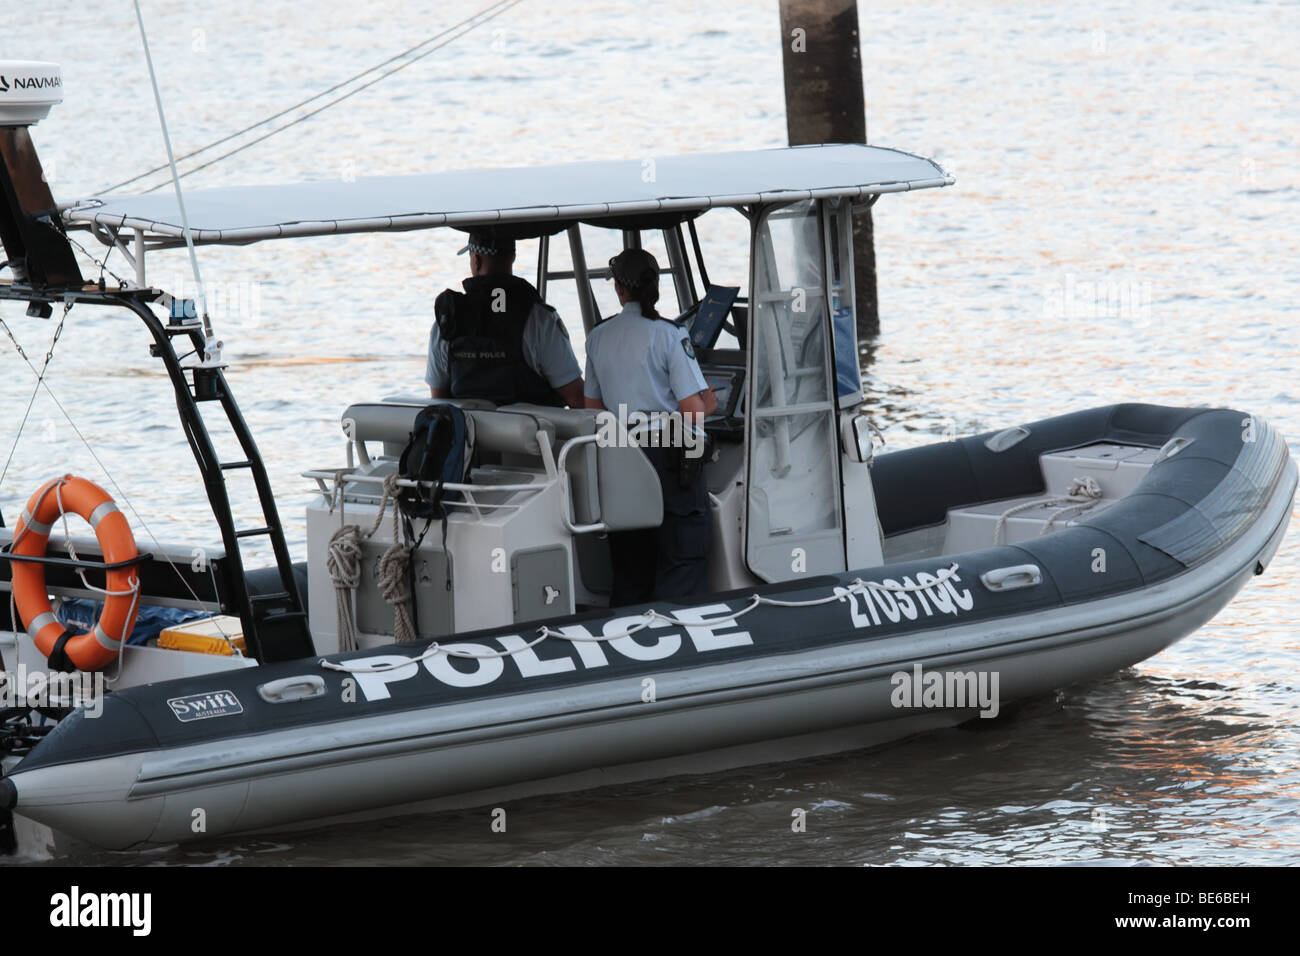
[350, 604, 754, 701]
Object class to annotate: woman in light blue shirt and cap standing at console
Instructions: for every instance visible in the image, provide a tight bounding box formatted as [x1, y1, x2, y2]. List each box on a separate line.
[584, 248, 718, 607]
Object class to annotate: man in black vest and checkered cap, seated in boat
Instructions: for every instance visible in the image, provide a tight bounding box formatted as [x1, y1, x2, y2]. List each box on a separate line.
[424, 233, 582, 408]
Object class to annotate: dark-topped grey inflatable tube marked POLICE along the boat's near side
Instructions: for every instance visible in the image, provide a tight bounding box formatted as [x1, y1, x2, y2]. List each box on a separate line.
[0, 410, 1296, 848]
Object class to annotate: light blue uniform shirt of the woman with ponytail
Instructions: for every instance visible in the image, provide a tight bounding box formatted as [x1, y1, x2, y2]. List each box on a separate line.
[582, 302, 709, 412]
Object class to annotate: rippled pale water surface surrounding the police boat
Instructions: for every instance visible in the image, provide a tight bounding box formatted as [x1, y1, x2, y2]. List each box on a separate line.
[0, 0, 1300, 865]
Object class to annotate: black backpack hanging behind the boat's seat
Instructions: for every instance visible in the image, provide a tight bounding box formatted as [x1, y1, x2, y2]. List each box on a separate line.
[398, 403, 475, 520]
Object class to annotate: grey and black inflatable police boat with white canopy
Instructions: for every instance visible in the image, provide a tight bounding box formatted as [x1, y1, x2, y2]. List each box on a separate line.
[0, 64, 1296, 852]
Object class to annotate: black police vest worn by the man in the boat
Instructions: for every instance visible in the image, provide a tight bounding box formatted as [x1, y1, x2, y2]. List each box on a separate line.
[433, 276, 564, 406]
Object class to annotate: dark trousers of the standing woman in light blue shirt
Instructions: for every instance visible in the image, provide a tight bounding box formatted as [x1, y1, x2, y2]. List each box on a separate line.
[610, 447, 712, 607]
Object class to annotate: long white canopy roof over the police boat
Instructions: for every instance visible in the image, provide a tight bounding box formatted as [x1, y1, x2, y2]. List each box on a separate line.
[62, 144, 953, 248]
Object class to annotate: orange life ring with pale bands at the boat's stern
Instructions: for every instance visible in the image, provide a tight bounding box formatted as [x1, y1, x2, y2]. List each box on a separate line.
[12, 475, 139, 671]
